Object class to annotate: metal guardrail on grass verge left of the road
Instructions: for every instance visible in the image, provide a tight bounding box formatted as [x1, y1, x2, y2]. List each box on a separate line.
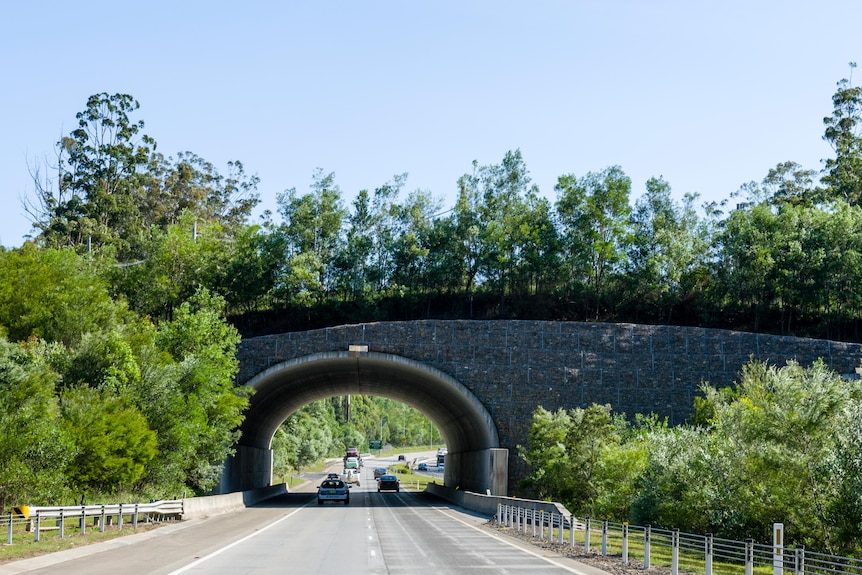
[0, 499, 183, 545]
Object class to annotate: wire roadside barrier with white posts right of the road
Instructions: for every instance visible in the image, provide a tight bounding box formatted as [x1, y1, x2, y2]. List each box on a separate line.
[496, 503, 862, 575]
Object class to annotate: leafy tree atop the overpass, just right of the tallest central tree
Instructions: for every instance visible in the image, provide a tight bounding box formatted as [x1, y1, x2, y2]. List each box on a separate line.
[554, 166, 631, 317]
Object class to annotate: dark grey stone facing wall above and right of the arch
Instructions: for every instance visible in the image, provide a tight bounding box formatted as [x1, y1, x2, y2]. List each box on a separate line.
[238, 320, 862, 486]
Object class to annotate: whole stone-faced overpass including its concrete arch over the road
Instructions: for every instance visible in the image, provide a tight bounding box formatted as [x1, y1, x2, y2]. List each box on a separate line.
[224, 320, 862, 495]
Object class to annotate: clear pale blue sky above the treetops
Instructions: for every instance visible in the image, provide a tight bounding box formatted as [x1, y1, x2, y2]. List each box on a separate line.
[0, 0, 862, 247]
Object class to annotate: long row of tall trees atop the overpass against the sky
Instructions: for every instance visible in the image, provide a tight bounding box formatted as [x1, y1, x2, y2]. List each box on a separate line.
[20, 74, 862, 340]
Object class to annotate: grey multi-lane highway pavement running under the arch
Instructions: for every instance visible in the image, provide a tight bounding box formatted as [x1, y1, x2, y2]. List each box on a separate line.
[0, 459, 595, 575]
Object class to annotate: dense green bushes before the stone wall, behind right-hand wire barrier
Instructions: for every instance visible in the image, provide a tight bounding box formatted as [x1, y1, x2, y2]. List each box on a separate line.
[520, 361, 862, 554]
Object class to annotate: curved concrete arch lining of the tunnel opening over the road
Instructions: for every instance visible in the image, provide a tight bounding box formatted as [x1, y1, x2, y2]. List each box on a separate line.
[220, 351, 508, 494]
